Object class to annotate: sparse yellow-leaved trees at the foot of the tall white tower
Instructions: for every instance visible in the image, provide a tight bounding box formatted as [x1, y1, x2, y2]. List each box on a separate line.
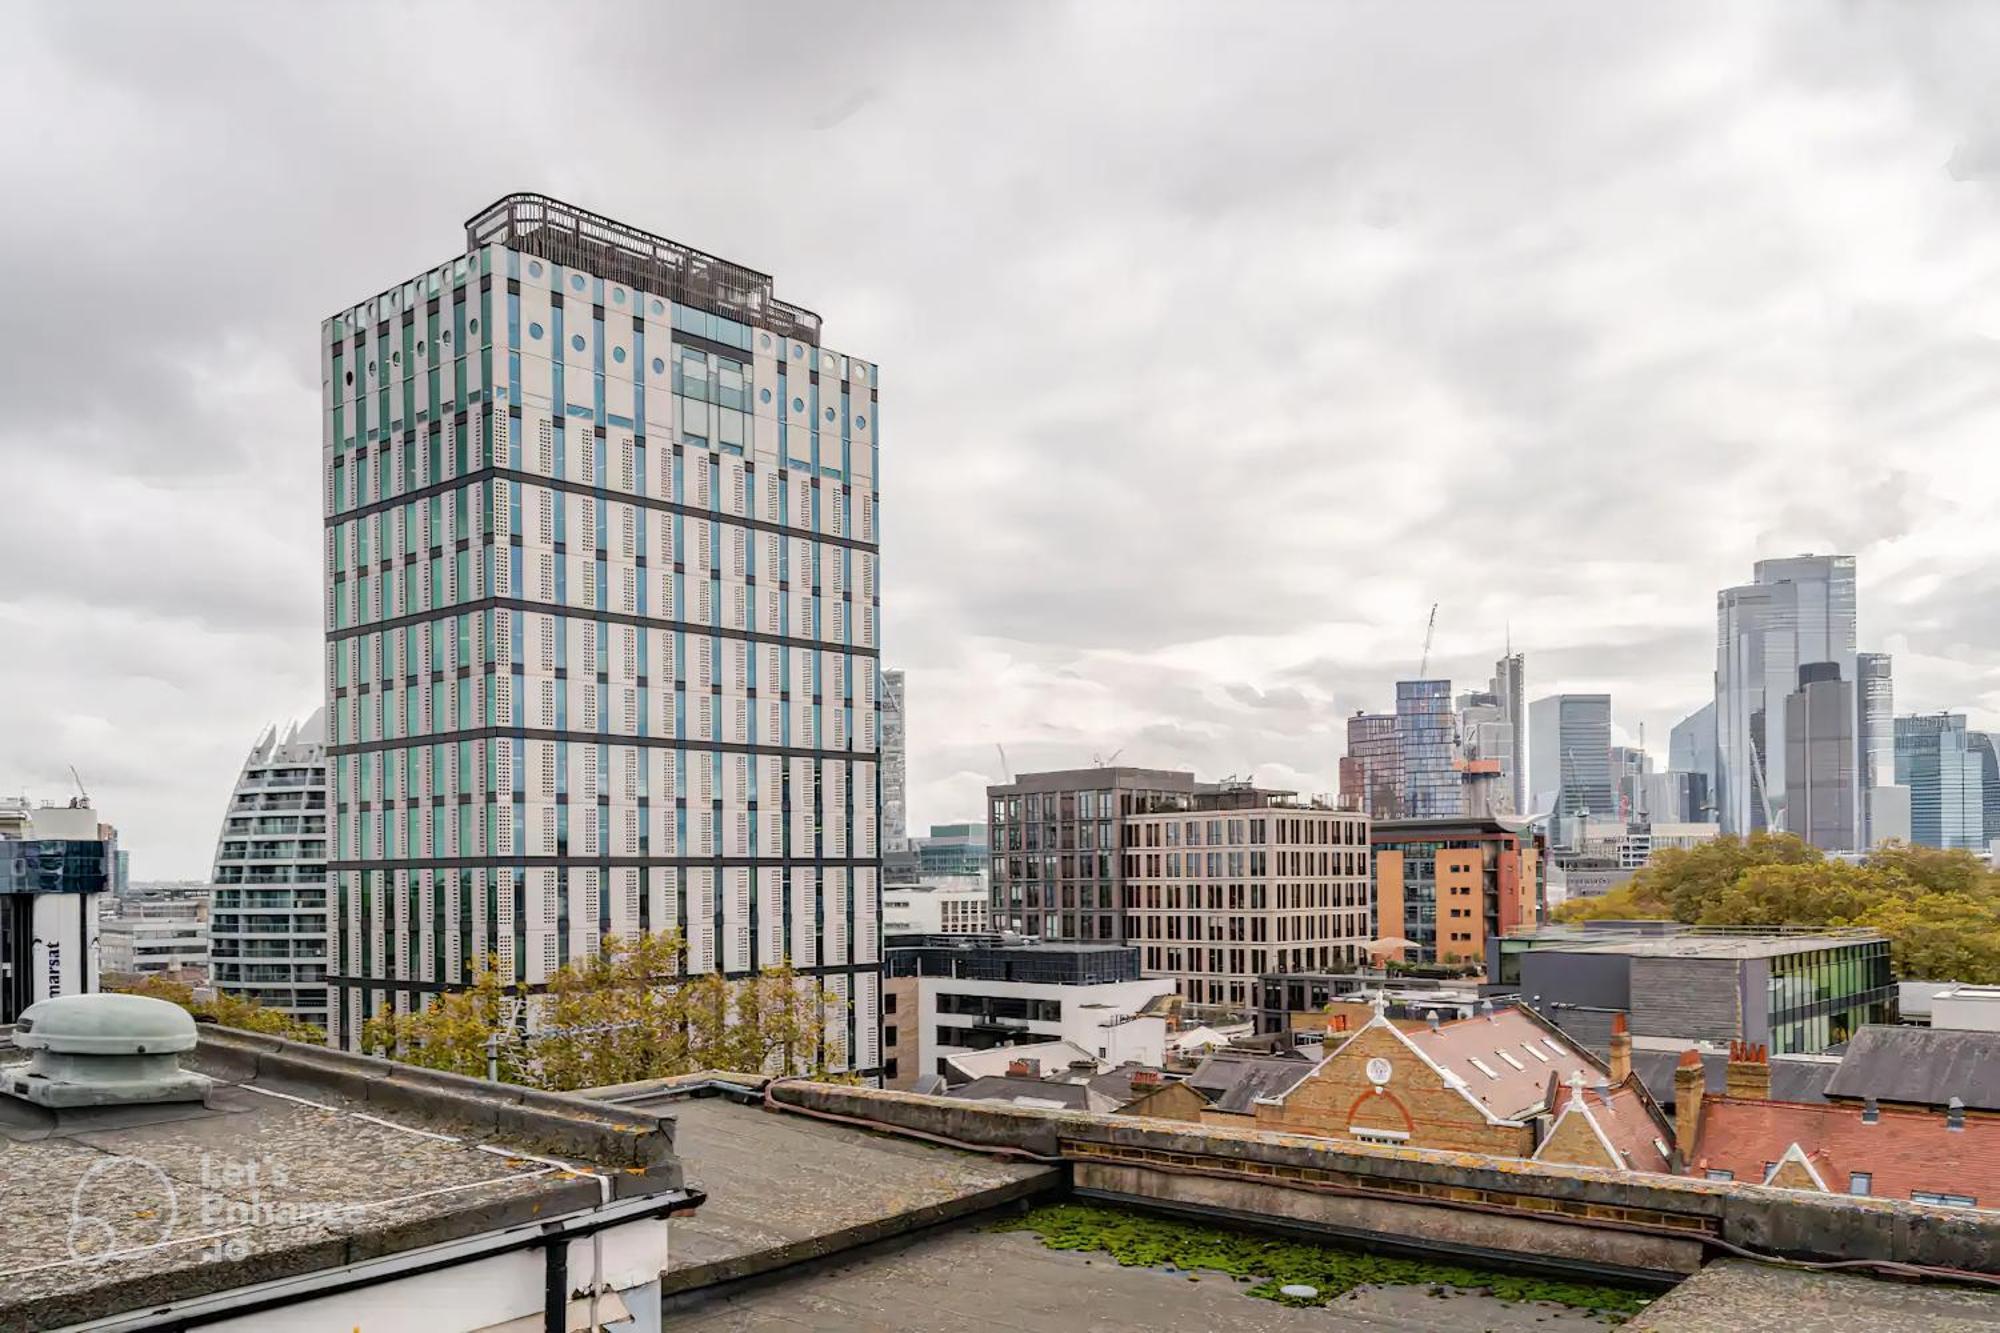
[362, 931, 842, 1091]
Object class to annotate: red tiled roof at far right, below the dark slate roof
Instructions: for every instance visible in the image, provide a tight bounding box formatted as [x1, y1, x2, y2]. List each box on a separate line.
[1688, 1093, 2000, 1207]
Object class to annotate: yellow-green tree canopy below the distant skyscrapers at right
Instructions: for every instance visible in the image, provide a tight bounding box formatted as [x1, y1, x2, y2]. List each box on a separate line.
[1556, 833, 2000, 985]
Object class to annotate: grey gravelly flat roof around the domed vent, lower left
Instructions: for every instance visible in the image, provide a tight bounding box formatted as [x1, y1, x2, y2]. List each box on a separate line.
[0, 1029, 698, 1327]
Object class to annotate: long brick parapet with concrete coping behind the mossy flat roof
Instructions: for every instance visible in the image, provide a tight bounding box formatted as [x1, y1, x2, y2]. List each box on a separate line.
[770, 1081, 2000, 1273]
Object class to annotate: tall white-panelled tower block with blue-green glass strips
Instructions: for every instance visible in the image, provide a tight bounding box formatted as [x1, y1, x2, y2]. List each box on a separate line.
[322, 194, 880, 1071]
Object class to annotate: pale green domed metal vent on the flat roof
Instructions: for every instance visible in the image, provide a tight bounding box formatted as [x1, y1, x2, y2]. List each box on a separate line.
[0, 995, 208, 1109]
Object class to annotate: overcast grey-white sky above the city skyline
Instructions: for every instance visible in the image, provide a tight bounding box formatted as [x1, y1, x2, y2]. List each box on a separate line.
[0, 2, 2000, 879]
